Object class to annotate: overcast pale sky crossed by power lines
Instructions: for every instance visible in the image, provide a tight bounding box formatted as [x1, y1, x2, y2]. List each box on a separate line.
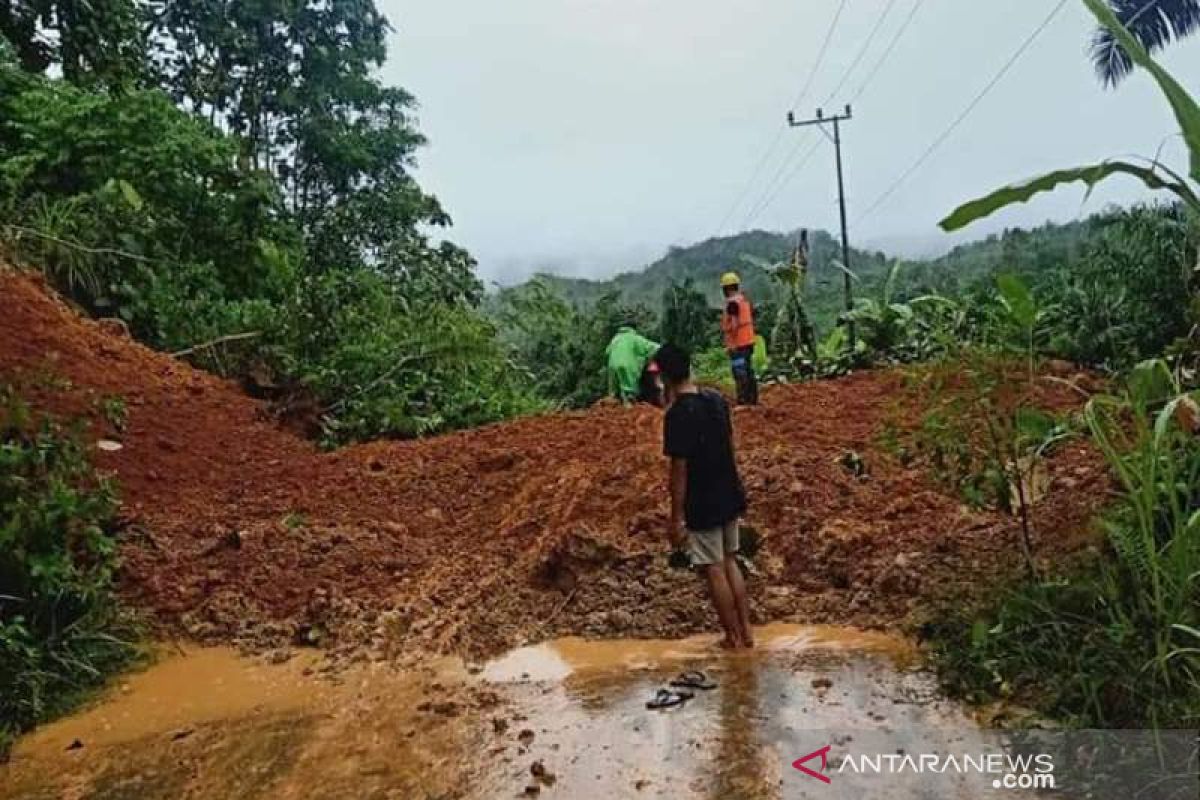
[379, 0, 1200, 283]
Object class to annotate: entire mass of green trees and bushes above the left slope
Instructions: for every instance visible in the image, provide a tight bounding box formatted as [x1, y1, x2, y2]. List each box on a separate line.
[0, 0, 518, 441]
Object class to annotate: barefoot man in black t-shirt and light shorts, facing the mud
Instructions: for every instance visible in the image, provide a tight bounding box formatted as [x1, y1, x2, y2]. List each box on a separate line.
[654, 344, 754, 648]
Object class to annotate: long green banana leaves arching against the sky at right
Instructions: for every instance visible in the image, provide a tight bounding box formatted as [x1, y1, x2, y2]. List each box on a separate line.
[940, 0, 1200, 260]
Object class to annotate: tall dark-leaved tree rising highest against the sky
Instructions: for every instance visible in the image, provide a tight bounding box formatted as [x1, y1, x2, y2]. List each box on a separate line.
[145, 0, 472, 303]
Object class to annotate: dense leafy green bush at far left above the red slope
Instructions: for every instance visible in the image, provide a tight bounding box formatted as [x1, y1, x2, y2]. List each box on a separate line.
[0, 60, 299, 331]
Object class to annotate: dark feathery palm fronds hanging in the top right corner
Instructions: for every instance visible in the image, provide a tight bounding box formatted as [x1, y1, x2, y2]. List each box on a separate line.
[1092, 0, 1200, 86]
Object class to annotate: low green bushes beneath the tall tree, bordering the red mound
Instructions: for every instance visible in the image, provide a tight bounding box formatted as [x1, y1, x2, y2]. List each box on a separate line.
[283, 269, 545, 444]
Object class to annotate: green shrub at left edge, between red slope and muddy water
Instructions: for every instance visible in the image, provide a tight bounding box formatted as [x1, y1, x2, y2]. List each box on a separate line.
[0, 386, 136, 738]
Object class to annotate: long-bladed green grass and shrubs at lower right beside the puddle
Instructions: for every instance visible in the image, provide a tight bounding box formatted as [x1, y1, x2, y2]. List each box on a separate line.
[931, 361, 1200, 727]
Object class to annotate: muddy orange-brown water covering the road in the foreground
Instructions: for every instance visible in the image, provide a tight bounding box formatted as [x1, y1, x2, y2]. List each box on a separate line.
[0, 625, 1041, 800]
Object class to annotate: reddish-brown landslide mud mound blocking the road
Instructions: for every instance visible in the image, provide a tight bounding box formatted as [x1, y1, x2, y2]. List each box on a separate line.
[0, 271, 1106, 657]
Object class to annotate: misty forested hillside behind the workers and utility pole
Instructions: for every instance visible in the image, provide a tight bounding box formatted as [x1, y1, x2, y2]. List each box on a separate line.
[499, 206, 1171, 383]
